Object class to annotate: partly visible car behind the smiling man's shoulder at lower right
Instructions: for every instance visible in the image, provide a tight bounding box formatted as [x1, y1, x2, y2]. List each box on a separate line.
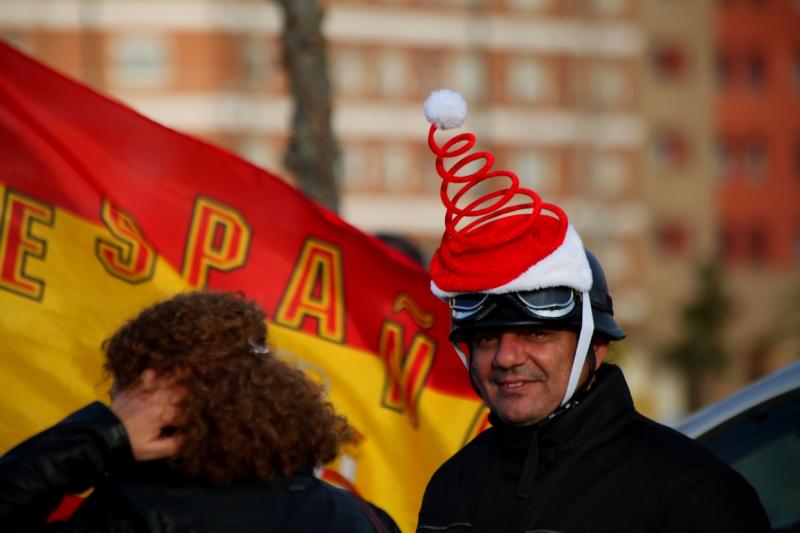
[676, 361, 800, 531]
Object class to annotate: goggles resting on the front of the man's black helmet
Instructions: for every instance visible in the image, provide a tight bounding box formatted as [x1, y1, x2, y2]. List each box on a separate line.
[448, 287, 578, 321]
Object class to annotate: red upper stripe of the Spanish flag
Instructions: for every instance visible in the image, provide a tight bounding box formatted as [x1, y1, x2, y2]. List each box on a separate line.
[0, 42, 474, 398]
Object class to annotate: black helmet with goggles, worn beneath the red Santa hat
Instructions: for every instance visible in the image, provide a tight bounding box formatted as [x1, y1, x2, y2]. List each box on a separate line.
[448, 249, 625, 343]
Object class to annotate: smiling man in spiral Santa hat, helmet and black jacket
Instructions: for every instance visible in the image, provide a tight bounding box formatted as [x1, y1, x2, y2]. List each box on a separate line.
[417, 91, 769, 533]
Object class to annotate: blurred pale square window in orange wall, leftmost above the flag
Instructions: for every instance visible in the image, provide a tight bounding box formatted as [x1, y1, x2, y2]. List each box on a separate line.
[111, 35, 172, 87]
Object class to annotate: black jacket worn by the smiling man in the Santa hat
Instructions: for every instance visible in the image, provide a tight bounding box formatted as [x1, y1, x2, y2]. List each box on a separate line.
[417, 364, 769, 533]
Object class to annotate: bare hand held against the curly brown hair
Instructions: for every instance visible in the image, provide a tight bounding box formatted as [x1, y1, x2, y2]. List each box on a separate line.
[109, 370, 185, 461]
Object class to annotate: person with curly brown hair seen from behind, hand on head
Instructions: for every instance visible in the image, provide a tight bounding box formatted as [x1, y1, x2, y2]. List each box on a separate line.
[0, 292, 399, 533]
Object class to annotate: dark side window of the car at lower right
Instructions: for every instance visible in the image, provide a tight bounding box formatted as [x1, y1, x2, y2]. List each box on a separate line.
[697, 390, 800, 529]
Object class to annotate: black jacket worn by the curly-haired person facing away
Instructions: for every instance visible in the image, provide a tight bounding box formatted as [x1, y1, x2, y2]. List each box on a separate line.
[0, 403, 399, 533]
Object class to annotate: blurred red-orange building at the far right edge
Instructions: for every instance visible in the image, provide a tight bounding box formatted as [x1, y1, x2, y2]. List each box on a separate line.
[713, 0, 800, 394]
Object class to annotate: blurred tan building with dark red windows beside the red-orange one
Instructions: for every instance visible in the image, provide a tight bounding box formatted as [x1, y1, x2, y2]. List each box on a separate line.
[626, 0, 714, 419]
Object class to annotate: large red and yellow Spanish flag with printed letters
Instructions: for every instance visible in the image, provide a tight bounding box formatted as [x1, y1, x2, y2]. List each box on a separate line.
[0, 43, 486, 531]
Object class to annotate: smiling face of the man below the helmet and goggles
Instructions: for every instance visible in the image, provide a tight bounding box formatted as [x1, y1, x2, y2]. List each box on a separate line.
[470, 327, 585, 426]
